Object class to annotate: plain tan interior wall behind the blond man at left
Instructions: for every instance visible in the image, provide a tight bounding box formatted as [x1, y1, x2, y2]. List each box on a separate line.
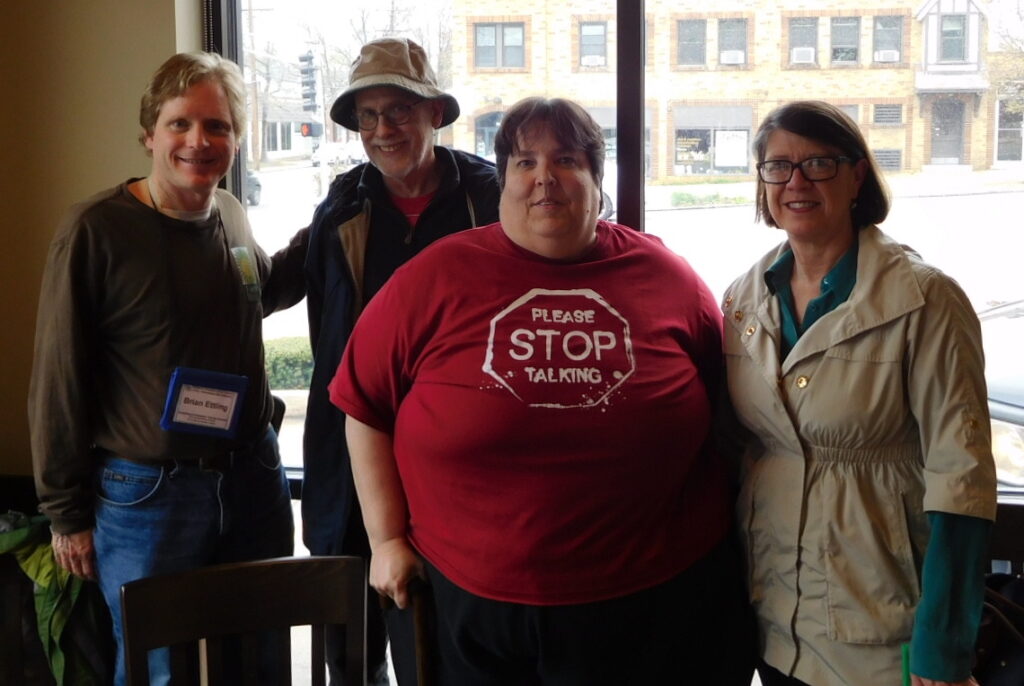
[0, 0, 201, 479]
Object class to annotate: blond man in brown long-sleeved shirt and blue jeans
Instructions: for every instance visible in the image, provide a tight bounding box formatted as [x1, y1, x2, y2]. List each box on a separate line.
[29, 53, 294, 686]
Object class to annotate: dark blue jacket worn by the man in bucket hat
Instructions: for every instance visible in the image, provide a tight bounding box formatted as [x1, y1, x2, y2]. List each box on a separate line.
[302, 147, 499, 555]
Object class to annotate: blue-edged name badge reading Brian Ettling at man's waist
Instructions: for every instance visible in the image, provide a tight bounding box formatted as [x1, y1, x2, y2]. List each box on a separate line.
[160, 367, 249, 438]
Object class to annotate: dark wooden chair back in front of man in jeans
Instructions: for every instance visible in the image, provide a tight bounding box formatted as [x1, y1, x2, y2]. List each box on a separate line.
[121, 557, 367, 686]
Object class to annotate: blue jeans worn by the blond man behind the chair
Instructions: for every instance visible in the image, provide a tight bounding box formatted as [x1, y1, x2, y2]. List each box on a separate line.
[93, 429, 295, 686]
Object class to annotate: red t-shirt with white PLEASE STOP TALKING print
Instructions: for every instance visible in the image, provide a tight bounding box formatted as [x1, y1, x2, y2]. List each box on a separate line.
[329, 222, 730, 605]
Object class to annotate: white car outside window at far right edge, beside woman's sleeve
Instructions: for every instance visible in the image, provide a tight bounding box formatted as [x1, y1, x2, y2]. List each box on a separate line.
[978, 300, 1024, 494]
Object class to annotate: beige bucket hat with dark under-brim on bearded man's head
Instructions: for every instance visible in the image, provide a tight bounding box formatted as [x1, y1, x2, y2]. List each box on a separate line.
[331, 38, 459, 131]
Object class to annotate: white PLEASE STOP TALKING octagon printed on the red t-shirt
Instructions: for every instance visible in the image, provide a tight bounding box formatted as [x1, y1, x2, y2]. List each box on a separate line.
[483, 289, 635, 408]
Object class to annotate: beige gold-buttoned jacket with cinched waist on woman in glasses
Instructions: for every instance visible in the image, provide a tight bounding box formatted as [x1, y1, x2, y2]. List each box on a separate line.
[722, 226, 995, 686]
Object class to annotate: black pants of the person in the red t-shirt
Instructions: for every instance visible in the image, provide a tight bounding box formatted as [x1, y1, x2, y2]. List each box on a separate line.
[401, 541, 755, 686]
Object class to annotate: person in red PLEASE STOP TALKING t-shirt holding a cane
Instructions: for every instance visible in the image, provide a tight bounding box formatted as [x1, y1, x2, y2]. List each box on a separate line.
[330, 98, 754, 686]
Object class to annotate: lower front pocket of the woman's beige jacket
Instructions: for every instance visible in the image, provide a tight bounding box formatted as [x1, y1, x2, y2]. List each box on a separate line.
[824, 478, 921, 644]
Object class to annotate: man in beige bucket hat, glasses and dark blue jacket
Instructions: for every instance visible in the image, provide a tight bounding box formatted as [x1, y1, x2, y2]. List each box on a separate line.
[302, 38, 499, 684]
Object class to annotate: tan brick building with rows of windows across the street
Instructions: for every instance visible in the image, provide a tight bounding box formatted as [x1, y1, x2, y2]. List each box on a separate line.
[452, 0, 1021, 182]
